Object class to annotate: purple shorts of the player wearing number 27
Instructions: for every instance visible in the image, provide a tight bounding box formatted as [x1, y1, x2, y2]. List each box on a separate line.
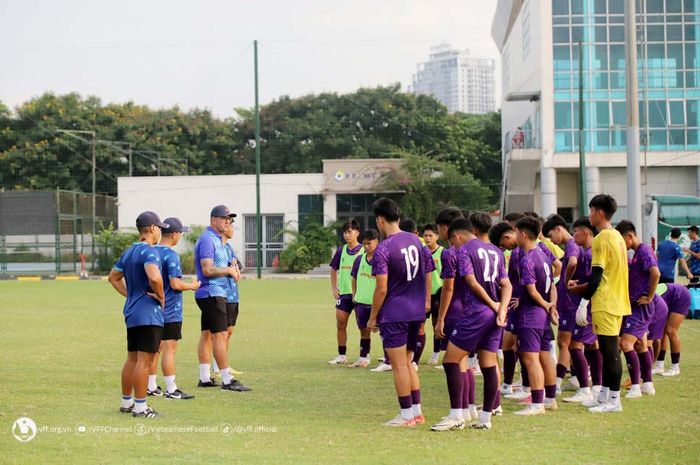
[449, 310, 503, 354]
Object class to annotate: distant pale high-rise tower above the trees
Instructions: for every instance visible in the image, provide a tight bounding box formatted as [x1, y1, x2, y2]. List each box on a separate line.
[409, 43, 496, 114]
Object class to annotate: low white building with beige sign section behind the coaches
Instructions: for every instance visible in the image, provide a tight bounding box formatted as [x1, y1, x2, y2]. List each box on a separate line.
[117, 159, 402, 268]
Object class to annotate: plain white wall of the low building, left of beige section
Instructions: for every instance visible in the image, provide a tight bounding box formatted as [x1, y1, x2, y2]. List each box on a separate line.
[118, 173, 323, 254]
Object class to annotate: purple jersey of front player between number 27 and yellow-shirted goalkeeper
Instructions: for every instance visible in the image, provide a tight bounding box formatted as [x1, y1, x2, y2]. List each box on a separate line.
[518, 247, 552, 329]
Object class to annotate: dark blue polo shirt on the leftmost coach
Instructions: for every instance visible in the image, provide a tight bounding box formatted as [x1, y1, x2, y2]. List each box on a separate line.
[114, 242, 163, 328]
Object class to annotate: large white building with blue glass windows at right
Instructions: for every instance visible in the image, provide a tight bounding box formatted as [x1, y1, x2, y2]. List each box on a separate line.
[492, 0, 700, 223]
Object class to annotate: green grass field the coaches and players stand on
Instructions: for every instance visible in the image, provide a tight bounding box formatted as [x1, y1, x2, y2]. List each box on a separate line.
[0, 280, 700, 465]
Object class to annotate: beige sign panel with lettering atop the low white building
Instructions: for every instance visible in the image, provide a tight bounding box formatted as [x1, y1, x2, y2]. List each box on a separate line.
[323, 158, 403, 193]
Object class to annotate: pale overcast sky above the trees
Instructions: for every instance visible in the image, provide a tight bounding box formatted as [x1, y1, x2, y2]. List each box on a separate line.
[0, 0, 500, 117]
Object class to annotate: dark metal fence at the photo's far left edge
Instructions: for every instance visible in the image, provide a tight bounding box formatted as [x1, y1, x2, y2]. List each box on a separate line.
[0, 190, 117, 274]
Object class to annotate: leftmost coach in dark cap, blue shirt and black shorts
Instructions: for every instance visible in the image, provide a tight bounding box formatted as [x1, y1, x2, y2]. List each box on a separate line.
[108, 212, 168, 418]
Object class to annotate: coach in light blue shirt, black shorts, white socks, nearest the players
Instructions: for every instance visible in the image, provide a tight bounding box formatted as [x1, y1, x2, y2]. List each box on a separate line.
[194, 205, 250, 391]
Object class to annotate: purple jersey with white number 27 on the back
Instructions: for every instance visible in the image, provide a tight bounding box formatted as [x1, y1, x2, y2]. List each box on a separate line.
[458, 239, 508, 313]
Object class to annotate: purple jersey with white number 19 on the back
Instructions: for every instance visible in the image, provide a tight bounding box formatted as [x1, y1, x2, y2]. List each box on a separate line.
[372, 231, 435, 325]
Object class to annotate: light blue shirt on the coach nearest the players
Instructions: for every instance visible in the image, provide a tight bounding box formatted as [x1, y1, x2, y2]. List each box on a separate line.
[194, 226, 228, 299]
